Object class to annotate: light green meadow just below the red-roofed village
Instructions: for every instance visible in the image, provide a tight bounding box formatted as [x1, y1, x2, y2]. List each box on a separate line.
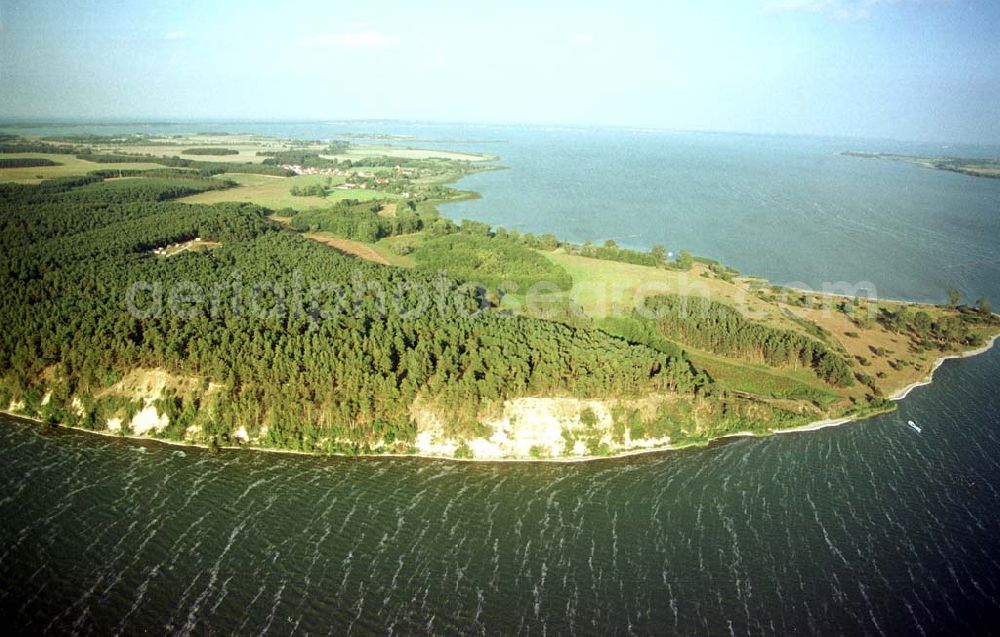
[179, 173, 396, 210]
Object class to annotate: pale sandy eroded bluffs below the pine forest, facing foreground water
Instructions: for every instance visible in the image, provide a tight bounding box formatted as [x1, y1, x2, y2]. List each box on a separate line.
[6, 369, 676, 460]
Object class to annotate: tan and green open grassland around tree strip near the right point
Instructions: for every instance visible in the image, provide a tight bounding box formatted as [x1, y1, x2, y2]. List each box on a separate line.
[540, 251, 992, 408]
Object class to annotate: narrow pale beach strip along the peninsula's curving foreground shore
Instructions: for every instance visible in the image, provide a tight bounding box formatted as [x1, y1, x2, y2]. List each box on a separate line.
[0, 334, 1000, 463]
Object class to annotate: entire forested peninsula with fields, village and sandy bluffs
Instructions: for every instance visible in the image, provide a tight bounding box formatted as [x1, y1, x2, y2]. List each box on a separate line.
[0, 133, 1000, 461]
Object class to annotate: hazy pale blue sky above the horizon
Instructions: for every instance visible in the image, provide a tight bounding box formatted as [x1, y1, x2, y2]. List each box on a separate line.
[0, 0, 1000, 143]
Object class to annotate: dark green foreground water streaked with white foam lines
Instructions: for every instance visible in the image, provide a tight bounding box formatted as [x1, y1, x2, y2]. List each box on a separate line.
[0, 350, 1000, 635]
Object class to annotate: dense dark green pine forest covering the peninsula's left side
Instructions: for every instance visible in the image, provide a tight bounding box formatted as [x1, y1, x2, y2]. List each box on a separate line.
[0, 170, 705, 451]
